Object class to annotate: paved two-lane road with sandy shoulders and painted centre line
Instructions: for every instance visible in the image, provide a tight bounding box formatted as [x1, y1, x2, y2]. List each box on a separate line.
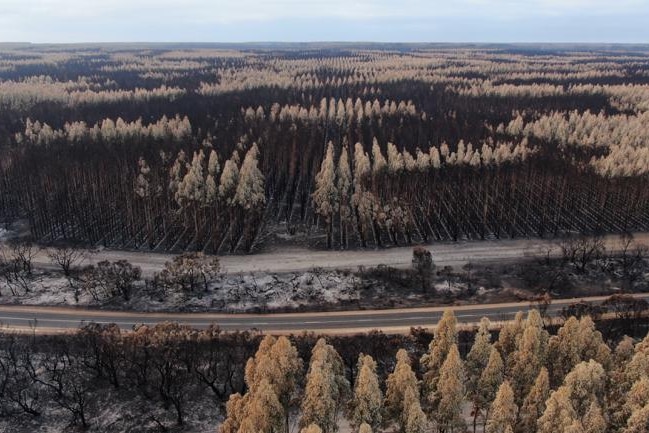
[0, 294, 649, 335]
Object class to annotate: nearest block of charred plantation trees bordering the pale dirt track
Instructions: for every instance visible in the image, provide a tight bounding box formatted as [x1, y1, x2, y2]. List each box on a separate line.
[2, 118, 649, 253]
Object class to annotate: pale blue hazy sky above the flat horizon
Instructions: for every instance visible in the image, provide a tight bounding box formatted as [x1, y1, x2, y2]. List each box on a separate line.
[0, 0, 649, 43]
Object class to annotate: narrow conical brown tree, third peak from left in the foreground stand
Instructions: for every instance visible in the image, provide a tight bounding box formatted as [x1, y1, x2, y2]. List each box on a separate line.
[352, 354, 383, 429]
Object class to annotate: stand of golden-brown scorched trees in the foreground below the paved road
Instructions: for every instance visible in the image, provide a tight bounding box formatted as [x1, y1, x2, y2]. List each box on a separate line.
[219, 310, 649, 433]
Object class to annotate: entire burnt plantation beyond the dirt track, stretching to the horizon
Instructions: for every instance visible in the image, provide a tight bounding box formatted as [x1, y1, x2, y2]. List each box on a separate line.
[0, 48, 649, 253]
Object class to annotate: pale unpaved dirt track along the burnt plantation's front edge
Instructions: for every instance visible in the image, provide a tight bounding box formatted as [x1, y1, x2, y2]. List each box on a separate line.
[5, 233, 649, 275]
